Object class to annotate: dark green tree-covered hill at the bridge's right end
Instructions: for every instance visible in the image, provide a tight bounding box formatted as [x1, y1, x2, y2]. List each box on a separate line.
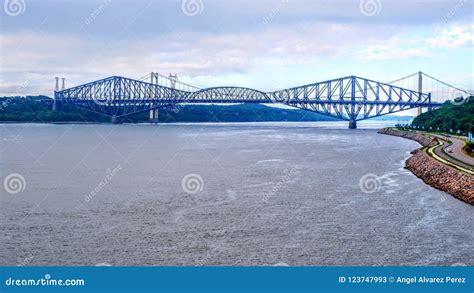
[412, 96, 474, 133]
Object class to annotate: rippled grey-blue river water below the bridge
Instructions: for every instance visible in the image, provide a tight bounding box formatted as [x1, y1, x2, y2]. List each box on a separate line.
[0, 123, 474, 266]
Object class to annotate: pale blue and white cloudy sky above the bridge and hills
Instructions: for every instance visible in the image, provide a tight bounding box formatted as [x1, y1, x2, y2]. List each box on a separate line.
[0, 0, 474, 95]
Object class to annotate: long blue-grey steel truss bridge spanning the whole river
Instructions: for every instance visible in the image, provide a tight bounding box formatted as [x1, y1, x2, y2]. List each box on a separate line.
[53, 72, 468, 128]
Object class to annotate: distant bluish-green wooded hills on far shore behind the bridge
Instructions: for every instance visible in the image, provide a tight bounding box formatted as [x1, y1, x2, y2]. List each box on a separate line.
[0, 96, 338, 123]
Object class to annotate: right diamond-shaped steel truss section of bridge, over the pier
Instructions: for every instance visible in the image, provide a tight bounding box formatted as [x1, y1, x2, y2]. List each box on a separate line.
[269, 76, 437, 121]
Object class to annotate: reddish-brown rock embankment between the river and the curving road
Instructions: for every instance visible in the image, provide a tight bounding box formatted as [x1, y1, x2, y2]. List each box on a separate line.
[378, 128, 474, 205]
